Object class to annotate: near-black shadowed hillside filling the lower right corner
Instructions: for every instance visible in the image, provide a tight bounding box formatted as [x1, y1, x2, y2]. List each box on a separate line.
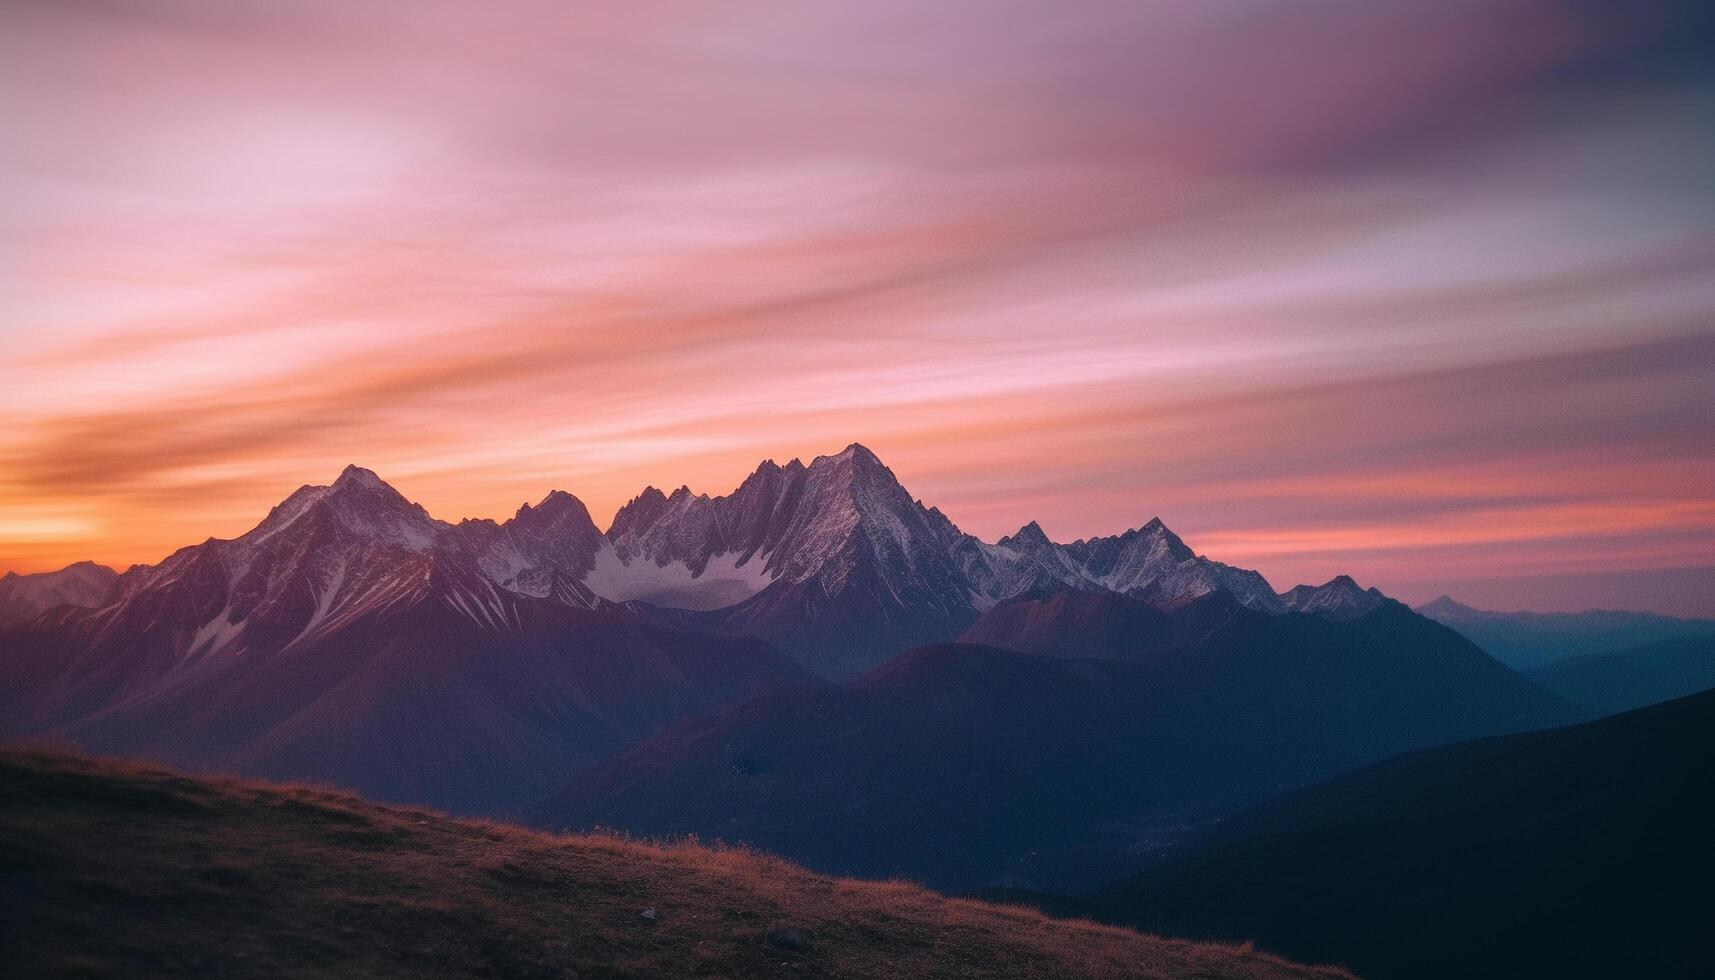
[1079, 692, 1715, 980]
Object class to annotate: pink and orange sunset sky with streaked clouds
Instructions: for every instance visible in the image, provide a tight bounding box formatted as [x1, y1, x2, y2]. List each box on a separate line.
[0, 0, 1715, 614]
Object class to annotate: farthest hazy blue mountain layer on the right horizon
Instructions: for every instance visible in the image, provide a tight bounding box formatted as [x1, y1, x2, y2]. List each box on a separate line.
[1417, 596, 1715, 671]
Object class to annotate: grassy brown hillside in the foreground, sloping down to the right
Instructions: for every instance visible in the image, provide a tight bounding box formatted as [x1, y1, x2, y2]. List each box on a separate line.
[0, 752, 1346, 980]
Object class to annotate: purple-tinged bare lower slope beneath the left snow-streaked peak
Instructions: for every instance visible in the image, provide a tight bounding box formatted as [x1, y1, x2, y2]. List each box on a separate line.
[5, 599, 808, 814]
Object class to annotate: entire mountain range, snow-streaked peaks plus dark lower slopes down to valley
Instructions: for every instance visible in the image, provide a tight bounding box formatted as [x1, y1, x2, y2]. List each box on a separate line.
[0, 445, 1590, 887]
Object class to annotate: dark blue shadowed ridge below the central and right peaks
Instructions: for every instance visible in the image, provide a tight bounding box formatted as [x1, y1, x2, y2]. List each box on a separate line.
[542, 592, 1576, 887]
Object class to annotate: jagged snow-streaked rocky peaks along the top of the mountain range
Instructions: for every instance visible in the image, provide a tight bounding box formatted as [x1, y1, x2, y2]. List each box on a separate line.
[0, 445, 1310, 680]
